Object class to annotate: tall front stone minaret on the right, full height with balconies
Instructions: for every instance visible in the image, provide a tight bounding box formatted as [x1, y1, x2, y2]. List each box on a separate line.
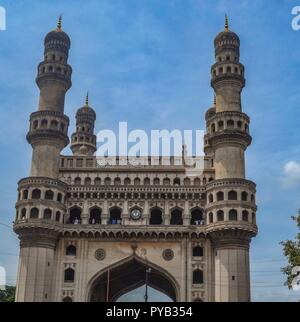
[205, 16, 257, 302]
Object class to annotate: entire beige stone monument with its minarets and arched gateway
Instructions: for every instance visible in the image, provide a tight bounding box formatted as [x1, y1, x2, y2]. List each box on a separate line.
[14, 19, 257, 302]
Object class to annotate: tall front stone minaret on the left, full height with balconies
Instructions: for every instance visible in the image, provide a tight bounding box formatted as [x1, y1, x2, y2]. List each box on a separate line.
[14, 17, 72, 302]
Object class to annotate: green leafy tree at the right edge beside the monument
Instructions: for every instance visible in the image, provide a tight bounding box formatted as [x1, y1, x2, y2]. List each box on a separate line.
[281, 210, 300, 289]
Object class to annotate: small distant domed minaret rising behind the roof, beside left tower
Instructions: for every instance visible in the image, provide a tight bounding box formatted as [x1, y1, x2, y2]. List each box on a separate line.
[71, 94, 96, 155]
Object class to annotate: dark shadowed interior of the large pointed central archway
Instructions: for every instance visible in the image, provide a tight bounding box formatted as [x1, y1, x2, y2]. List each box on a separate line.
[88, 256, 178, 302]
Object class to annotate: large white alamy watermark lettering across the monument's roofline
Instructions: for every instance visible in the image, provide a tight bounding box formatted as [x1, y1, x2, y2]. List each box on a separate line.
[96, 122, 205, 176]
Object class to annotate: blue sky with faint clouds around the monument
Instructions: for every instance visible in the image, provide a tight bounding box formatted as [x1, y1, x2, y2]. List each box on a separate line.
[0, 0, 300, 301]
